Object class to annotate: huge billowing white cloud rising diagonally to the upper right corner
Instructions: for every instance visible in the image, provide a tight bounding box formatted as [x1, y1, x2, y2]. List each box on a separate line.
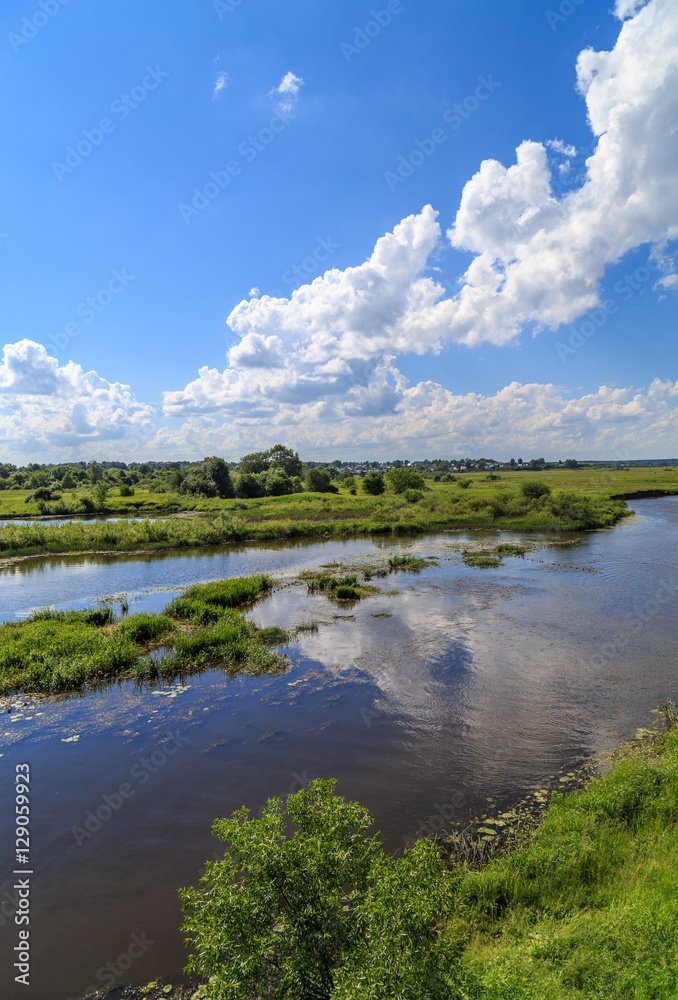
[215, 0, 678, 364]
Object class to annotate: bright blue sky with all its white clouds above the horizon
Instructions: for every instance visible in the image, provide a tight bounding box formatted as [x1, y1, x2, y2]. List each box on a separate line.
[0, 0, 678, 461]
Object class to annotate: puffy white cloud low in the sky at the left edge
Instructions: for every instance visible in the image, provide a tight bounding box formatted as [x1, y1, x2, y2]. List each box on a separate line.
[0, 340, 154, 460]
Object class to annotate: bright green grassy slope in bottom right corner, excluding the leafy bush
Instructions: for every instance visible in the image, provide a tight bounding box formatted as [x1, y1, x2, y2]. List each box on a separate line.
[449, 728, 678, 1000]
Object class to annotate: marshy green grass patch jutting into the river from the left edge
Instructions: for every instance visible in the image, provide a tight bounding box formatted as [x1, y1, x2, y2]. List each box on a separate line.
[0, 576, 285, 694]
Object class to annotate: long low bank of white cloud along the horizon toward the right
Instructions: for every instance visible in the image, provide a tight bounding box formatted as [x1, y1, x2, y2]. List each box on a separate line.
[157, 370, 678, 459]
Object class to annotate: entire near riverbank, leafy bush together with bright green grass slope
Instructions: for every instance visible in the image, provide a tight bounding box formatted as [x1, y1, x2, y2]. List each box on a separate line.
[181, 710, 678, 1000]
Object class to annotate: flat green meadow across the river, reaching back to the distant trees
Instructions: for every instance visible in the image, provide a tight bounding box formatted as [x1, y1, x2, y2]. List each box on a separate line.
[0, 467, 678, 558]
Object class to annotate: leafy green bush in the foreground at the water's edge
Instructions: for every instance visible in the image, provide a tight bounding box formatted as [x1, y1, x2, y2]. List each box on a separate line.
[180, 780, 458, 1000]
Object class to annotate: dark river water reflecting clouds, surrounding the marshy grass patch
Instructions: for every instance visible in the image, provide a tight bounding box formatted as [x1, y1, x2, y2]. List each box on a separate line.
[0, 498, 678, 1000]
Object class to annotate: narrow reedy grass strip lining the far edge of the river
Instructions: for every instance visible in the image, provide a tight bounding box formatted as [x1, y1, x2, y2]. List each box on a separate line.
[0, 473, 648, 558]
